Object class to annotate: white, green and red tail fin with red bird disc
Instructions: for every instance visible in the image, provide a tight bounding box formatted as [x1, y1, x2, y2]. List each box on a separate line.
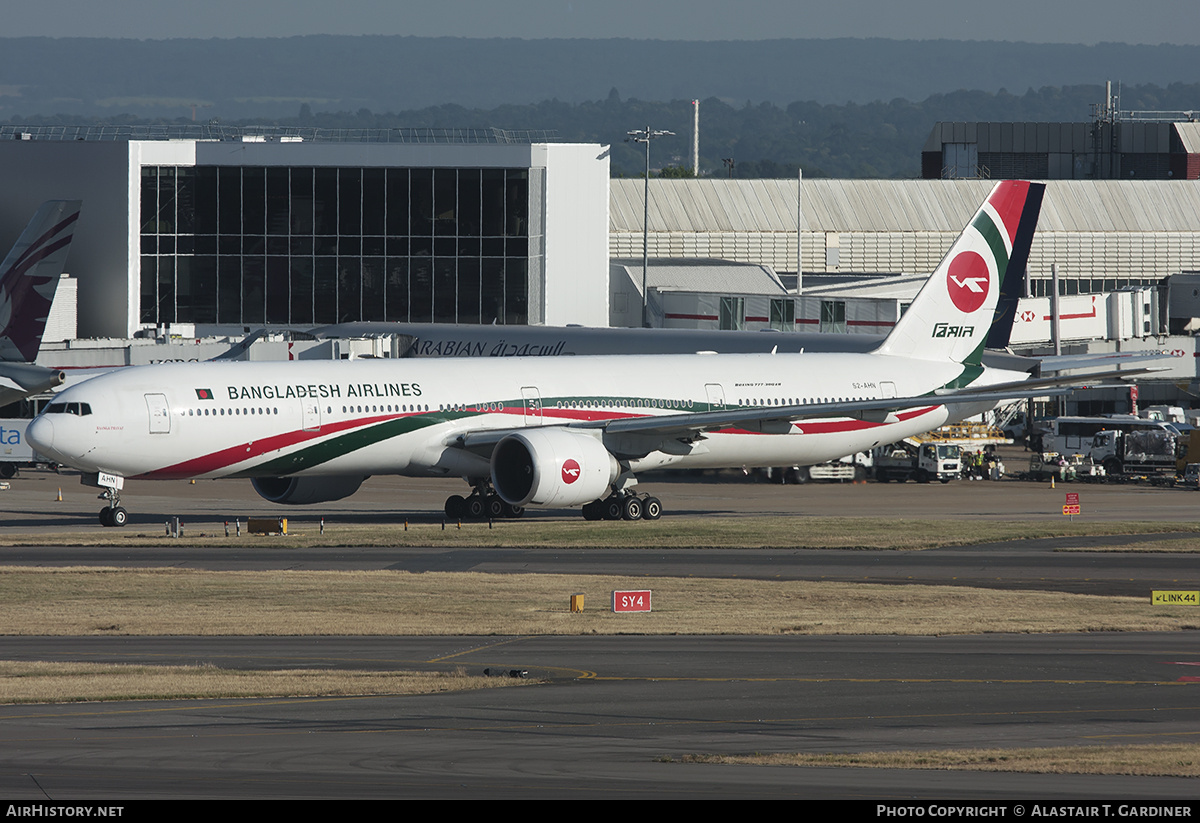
[877, 180, 1045, 366]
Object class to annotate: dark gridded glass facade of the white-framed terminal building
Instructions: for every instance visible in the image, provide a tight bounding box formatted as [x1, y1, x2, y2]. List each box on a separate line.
[139, 166, 545, 325]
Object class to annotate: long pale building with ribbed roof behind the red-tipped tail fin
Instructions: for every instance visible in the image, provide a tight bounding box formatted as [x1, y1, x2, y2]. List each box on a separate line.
[608, 179, 1200, 296]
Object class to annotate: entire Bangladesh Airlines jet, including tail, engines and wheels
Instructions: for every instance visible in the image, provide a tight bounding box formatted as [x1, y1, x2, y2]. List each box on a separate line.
[28, 181, 1099, 525]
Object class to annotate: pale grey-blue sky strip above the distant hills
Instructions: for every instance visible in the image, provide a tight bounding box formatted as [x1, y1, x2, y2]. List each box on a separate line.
[9, 0, 1200, 46]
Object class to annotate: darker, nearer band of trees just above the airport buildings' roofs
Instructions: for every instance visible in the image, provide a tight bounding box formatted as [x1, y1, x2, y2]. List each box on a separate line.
[8, 83, 1200, 179]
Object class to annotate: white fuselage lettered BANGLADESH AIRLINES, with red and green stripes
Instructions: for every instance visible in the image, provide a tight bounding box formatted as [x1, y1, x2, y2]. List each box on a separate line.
[29, 353, 1020, 477]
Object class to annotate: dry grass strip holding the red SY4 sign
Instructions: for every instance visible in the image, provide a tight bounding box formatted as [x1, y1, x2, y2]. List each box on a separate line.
[0, 566, 1200, 636]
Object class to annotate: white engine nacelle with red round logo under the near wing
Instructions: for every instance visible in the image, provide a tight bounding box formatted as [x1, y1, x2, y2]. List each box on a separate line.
[492, 428, 620, 506]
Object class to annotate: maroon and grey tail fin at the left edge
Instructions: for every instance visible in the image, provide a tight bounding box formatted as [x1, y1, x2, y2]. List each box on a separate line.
[0, 200, 80, 362]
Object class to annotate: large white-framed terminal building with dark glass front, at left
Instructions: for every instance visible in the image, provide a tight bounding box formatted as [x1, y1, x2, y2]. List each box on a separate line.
[0, 128, 608, 337]
